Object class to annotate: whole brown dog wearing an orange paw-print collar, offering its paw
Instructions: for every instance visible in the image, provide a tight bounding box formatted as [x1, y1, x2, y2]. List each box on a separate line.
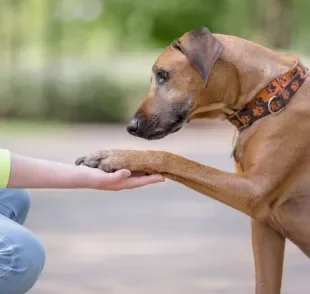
[76, 28, 310, 294]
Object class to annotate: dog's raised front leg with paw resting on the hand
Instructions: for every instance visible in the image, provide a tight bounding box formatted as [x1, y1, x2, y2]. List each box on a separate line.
[76, 150, 278, 217]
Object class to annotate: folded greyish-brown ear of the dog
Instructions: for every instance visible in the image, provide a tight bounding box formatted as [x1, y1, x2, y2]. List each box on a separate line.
[172, 27, 223, 83]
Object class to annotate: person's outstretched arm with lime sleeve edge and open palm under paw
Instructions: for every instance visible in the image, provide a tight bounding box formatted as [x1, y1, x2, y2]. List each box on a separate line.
[0, 149, 164, 191]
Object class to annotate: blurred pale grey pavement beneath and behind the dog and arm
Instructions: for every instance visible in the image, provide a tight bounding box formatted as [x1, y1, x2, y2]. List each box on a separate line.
[1, 121, 310, 294]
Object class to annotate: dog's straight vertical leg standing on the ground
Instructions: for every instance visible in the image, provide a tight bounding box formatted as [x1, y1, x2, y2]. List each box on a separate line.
[252, 219, 285, 294]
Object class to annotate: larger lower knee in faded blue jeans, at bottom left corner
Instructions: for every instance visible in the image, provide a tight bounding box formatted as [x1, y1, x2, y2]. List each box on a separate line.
[0, 227, 45, 294]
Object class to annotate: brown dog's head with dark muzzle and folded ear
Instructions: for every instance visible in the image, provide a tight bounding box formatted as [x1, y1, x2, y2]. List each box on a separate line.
[127, 28, 239, 140]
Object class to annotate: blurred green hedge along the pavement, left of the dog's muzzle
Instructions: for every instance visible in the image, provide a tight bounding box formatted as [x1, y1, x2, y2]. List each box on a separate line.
[0, 72, 128, 122]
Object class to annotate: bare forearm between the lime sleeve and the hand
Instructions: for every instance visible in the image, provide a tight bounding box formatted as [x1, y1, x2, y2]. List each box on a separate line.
[7, 150, 89, 189]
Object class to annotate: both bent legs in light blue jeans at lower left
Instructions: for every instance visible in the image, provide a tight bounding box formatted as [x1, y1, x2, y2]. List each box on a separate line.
[0, 189, 45, 294]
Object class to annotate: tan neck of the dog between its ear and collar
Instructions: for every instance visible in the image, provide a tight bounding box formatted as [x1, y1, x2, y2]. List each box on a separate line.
[214, 34, 296, 109]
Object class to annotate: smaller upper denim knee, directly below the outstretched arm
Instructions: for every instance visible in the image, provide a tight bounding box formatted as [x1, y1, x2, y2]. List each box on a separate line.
[0, 189, 31, 224]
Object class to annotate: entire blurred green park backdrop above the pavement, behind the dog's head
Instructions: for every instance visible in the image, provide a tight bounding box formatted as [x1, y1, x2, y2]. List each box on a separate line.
[0, 0, 310, 123]
